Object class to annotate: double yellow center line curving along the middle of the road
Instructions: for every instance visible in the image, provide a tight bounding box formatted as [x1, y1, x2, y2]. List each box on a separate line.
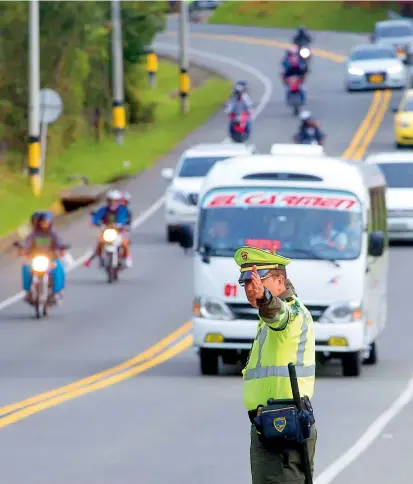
[0, 33, 391, 427]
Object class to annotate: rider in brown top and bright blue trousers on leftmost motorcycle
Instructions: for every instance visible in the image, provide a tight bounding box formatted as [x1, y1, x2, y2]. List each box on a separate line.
[18, 212, 67, 304]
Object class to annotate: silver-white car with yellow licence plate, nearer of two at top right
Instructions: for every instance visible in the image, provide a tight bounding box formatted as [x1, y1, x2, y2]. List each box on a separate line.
[345, 45, 408, 91]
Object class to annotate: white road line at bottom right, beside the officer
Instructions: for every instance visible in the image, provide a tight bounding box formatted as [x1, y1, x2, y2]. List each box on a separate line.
[314, 375, 413, 484]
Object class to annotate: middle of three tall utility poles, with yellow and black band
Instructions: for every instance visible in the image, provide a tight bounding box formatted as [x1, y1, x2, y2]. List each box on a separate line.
[112, 0, 126, 145]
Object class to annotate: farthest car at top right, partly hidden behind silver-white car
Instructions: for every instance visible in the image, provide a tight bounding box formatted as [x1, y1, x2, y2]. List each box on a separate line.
[370, 19, 413, 62]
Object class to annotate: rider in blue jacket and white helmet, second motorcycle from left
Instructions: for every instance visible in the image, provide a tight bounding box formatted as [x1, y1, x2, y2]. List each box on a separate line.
[83, 190, 132, 268]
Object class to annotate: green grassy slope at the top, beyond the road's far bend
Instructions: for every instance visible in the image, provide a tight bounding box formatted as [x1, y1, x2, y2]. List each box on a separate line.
[209, 1, 398, 32]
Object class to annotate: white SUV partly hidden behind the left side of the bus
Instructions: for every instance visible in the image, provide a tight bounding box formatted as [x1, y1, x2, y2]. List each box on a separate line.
[161, 143, 256, 242]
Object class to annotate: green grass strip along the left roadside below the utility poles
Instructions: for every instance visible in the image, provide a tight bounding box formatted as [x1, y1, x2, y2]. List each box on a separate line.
[0, 60, 231, 235]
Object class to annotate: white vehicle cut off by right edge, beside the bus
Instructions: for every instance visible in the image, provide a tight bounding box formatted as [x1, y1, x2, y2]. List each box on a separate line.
[365, 151, 413, 240]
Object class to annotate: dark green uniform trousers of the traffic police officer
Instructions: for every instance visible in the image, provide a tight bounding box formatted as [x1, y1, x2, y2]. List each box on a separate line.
[250, 425, 317, 484]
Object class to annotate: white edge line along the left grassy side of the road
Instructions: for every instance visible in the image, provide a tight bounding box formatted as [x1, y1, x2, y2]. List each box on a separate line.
[0, 43, 273, 311]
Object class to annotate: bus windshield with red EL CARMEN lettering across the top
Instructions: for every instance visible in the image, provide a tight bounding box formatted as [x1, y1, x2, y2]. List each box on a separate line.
[198, 188, 362, 260]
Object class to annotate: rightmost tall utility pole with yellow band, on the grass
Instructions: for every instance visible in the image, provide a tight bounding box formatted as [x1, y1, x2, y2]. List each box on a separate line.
[179, 0, 191, 113]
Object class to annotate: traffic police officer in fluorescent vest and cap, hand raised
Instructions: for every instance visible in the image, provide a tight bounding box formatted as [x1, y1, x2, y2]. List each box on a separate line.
[234, 247, 317, 484]
